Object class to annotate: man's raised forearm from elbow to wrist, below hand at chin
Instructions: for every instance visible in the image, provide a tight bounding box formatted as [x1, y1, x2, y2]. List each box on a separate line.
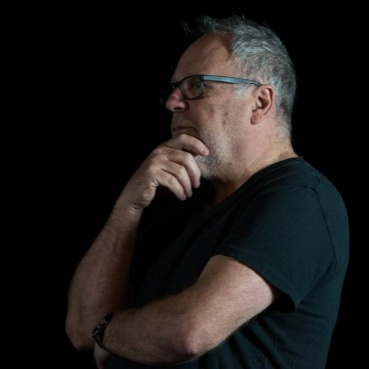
[66, 201, 140, 349]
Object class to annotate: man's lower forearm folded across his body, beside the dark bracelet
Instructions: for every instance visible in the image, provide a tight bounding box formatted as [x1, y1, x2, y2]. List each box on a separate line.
[103, 293, 207, 365]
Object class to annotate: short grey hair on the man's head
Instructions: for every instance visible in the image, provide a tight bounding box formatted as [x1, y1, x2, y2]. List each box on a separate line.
[182, 15, 296, 138]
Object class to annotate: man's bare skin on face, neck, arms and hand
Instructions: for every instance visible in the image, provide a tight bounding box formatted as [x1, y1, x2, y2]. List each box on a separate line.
[66, 35, 296, 369]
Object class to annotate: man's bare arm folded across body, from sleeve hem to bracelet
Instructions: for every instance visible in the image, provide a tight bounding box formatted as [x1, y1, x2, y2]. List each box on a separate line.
[100, 255, 278, 365]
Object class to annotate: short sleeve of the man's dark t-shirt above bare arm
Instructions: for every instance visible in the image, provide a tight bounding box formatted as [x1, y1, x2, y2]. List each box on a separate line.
[214, 186, 333, 310]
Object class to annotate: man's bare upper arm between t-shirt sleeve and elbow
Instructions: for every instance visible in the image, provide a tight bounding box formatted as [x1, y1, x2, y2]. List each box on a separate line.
[183, 255, 278, 351]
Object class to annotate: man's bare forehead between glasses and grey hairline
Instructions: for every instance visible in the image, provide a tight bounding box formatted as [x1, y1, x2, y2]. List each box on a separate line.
[174, 34, 236, 79]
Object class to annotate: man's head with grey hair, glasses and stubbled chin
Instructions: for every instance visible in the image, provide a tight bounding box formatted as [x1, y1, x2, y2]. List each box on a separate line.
[164, 17, 295, 181]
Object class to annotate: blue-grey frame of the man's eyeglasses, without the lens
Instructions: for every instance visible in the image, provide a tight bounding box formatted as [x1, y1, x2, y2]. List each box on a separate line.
[160, 74, 261, 104]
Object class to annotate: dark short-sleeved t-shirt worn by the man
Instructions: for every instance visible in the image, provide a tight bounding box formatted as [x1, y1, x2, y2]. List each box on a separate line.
[107, 157, 349, 369]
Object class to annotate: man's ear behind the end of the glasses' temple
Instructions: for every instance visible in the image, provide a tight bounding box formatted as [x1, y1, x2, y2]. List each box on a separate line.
[251, 85, 275, 124]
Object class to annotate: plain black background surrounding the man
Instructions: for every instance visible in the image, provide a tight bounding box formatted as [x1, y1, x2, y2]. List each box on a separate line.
[1, 0, 368, 369]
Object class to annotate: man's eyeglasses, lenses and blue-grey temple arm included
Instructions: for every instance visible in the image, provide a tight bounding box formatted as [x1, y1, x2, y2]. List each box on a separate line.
[160, 74, 260, 104]
